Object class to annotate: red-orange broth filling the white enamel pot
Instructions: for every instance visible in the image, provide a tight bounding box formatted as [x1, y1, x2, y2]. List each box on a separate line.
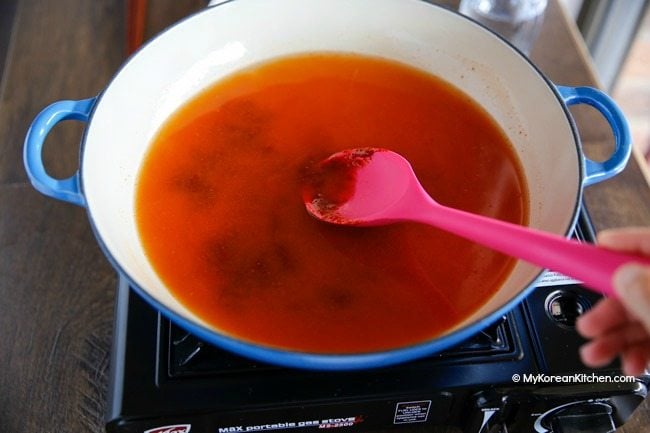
[136, 53, 528, 353]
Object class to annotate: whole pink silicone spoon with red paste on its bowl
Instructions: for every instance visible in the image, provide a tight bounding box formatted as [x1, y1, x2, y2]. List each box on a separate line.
[303, 148, 650, 297]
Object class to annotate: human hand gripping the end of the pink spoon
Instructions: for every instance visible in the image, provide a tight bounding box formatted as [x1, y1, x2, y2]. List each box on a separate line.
[576, 227, 650, 376]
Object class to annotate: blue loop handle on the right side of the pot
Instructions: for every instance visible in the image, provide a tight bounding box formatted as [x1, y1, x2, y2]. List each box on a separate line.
[556, 86, 632, 186]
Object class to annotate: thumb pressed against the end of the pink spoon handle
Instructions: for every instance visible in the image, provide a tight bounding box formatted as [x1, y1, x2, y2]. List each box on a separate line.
[613, 265, 650, 334]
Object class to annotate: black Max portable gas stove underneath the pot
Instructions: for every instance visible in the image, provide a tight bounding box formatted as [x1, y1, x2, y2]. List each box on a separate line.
[106, 212, 648, 433]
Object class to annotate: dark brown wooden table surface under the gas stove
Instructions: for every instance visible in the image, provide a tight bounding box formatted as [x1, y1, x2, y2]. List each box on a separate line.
[0, 0, 650, 433]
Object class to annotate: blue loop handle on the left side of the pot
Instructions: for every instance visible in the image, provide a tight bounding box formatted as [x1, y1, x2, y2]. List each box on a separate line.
[23, 98, 97, 206]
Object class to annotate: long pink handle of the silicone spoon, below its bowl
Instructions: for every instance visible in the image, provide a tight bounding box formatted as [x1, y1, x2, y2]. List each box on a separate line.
[409, 196, 650, 298]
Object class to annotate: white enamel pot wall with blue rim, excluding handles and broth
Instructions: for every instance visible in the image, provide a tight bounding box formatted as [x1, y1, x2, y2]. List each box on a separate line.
[26, 0, 618, 369]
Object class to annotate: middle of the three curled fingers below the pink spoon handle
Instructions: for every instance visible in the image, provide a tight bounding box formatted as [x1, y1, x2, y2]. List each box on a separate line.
[580, 323, 650, 367]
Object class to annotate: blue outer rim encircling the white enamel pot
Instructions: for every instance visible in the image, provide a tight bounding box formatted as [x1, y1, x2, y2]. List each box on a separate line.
[79, 0, 585, 371]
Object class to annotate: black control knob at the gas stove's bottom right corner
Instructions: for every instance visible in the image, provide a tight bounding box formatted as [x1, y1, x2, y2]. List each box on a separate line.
[535, 401, 616, 433]
